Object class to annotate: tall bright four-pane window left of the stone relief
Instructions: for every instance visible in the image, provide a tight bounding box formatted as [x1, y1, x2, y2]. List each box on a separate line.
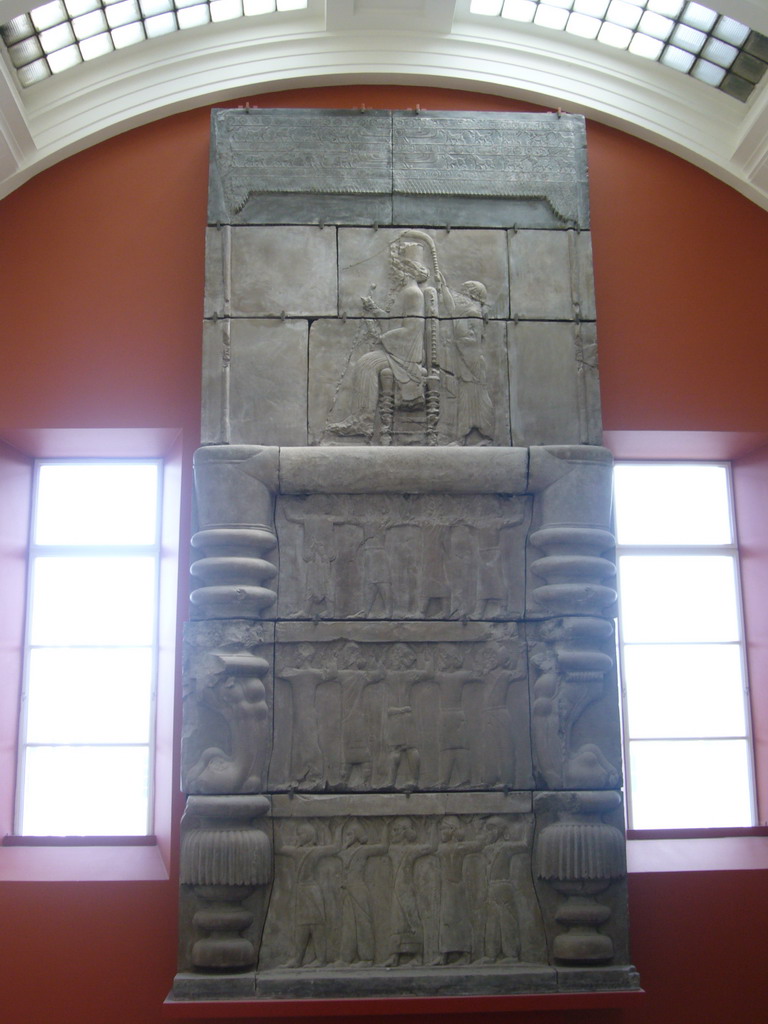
[16, 459, 162, 836]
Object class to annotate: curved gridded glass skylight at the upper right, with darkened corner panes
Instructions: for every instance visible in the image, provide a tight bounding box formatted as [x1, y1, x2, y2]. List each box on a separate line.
[470, 0, 768, 101]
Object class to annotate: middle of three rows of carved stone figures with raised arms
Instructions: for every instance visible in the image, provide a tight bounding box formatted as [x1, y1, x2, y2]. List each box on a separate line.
[278, 641, 528, 790]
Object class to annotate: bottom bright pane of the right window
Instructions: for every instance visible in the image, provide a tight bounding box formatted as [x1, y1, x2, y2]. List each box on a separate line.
[630, 739, 753, 828]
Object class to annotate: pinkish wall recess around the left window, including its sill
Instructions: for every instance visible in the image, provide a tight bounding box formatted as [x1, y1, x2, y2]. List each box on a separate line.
[0, 427, 186, 882]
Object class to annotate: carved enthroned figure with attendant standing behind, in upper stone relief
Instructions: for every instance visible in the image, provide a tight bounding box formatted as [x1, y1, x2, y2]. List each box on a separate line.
[323, 229, 495, 444]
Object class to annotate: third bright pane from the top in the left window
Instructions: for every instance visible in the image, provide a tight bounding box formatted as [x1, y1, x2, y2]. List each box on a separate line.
[27, 647, 153, 743]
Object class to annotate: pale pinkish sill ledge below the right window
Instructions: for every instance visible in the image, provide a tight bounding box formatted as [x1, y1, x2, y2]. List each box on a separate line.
[627, 826, 768, 874]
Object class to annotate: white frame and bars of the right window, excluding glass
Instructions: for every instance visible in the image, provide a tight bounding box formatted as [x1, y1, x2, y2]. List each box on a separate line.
[614, 457, 760, 837]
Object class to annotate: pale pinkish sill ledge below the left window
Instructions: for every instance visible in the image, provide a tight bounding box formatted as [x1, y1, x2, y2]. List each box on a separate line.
[0, 836, 169, 882]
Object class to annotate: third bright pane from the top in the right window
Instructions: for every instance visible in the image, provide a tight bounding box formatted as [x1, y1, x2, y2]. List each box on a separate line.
[624, 644, 746, 739]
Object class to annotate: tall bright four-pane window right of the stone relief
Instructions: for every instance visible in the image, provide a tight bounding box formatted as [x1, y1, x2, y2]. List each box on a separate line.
[614, 463, 755, 829]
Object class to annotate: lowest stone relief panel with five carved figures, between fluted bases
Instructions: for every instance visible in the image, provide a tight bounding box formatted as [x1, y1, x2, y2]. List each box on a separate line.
[260, 795, 547, 970]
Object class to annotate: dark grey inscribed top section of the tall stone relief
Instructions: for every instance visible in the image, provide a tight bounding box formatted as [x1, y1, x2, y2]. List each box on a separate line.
[209, 110, 589, 227]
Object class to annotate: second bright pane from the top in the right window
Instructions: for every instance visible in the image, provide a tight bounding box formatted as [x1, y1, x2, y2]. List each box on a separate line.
[618, 555, 739, 643]
